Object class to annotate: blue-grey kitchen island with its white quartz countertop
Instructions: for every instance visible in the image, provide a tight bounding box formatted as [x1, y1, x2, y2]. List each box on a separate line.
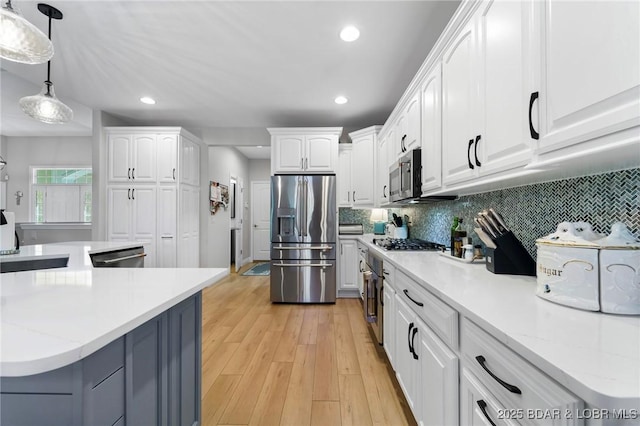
[0, 242, 228, 425]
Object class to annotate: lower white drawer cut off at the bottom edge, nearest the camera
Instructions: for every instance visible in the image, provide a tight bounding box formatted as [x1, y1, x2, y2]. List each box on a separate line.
[460, 366, 518, 426]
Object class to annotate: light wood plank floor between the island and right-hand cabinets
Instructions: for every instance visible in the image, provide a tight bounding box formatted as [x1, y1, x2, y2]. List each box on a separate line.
[202, 267, 415, 426]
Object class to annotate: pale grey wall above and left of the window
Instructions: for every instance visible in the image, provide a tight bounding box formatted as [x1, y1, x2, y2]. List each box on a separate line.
[2, 136, 92, 222]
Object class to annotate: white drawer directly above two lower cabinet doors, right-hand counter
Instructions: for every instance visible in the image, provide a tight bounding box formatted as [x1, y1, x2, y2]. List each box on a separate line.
[395, 271, 458, 349]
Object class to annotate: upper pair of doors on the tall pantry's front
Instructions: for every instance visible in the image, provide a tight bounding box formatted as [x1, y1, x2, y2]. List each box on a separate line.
[107, 134, 156, 182]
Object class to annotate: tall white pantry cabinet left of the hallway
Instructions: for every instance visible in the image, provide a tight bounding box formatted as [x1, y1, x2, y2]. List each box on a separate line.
[105, 127, 202, 268]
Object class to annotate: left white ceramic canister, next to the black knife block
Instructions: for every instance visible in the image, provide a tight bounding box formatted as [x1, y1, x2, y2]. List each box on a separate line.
[536, 222, 600, 311]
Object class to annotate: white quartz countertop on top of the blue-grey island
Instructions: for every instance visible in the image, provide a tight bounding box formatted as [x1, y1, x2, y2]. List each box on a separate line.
[0, 241, 228, 376]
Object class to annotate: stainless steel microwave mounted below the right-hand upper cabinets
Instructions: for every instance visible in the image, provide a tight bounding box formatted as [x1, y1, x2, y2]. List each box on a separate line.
[389, 149, 422, 202]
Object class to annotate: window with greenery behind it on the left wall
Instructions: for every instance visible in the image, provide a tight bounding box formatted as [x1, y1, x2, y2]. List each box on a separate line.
[31, 167, 93, 223]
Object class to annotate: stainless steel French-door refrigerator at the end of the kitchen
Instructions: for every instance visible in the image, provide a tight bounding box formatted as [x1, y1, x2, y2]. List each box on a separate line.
[271, 175, 337, 303]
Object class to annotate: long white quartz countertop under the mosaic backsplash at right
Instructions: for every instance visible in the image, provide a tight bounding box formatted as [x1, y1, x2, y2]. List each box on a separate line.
[348, 235, 640, 410]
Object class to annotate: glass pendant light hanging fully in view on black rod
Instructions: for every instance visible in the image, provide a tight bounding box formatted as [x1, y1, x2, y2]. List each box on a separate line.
[20, 3, 73, 124]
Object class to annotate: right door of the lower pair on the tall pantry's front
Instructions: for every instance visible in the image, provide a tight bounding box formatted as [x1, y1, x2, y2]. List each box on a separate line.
[129, 186, 156, 268]
